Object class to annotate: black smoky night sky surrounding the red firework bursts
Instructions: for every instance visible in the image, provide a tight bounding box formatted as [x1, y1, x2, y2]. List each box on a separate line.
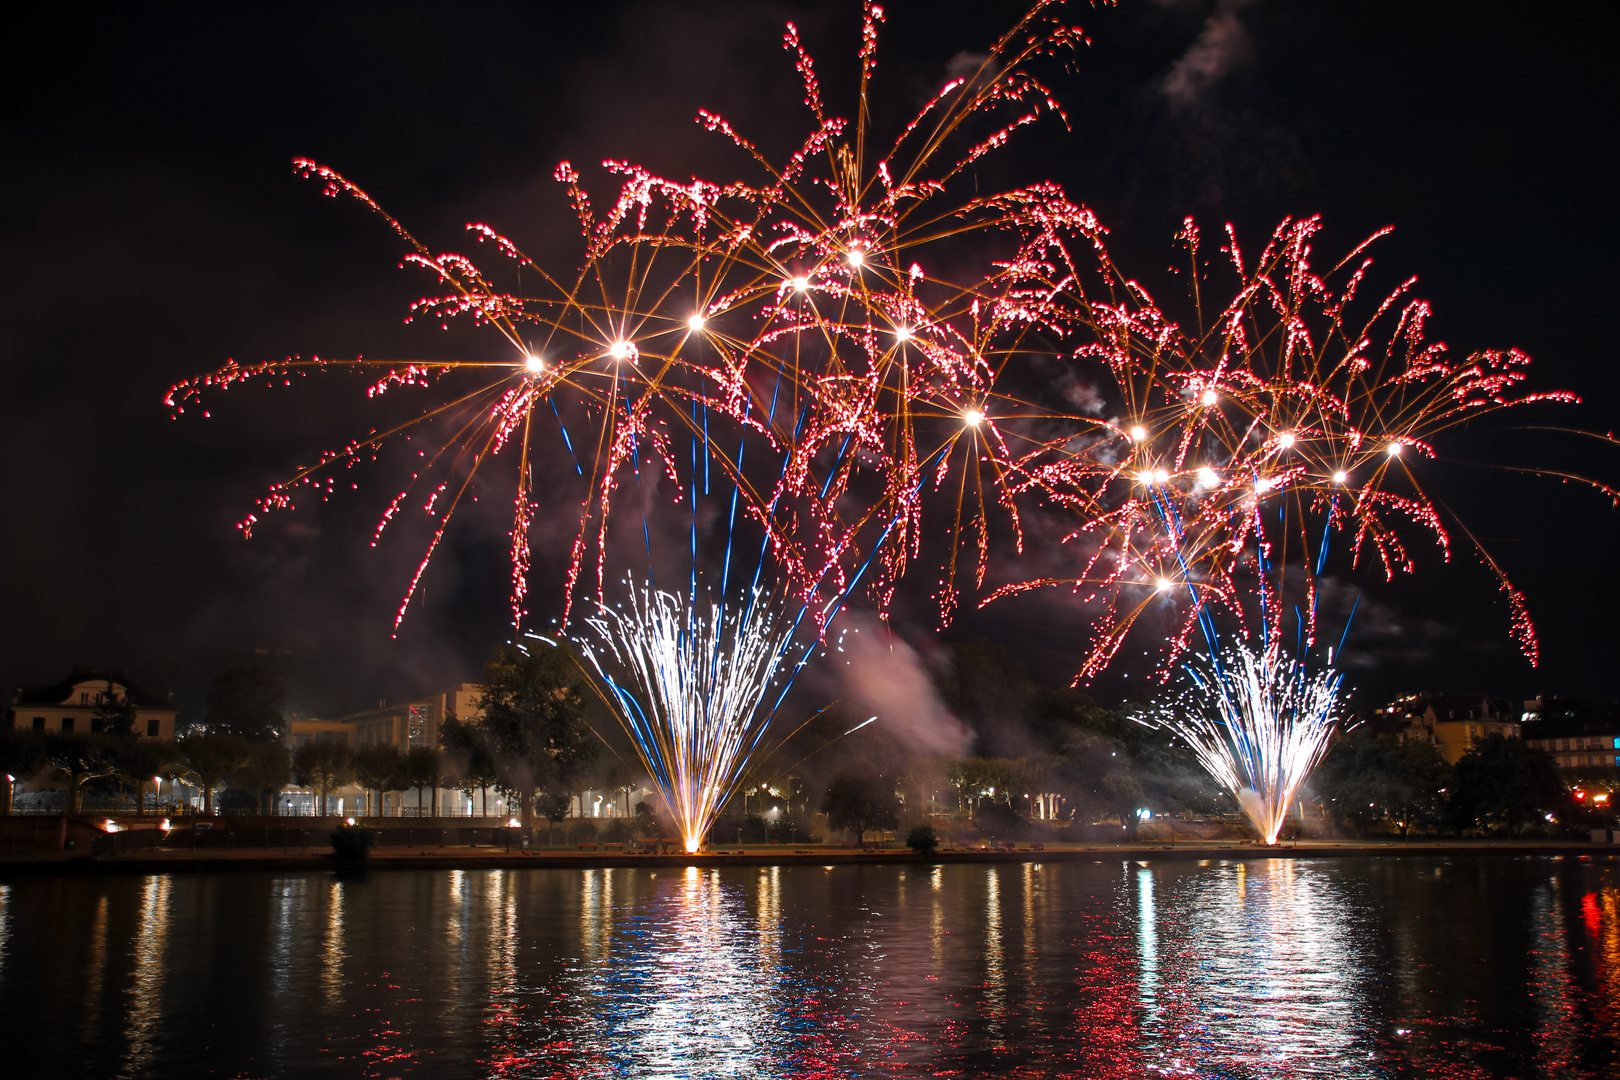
[0, 0, 1620, 722]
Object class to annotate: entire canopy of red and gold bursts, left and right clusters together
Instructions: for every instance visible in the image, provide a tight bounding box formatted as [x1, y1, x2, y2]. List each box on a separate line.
[168, 3, 1615, 693]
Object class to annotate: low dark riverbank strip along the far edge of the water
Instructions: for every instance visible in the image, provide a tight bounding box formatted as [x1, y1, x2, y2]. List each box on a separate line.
[0, 840, 1620, 881]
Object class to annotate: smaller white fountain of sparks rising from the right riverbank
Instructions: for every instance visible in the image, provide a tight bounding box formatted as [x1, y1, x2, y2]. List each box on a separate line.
[1144, 643, 1341, 844]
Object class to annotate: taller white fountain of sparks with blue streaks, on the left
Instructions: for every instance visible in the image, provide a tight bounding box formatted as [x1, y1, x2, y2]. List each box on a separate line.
[578, 586, 799, 852]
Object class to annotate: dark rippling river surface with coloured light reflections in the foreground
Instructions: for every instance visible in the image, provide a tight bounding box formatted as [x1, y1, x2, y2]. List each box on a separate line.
[0, 857, 1620, 1080]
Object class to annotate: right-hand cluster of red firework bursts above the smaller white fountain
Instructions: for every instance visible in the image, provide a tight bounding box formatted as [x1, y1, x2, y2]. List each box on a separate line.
[988, 219, 1615, 678]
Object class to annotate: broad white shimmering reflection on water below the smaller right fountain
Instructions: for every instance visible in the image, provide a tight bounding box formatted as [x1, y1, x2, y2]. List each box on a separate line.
[1137, 860, 1382, 1077]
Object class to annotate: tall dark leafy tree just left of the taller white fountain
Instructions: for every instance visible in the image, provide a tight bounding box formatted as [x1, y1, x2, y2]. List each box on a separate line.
[478, 644, 596, 829]
